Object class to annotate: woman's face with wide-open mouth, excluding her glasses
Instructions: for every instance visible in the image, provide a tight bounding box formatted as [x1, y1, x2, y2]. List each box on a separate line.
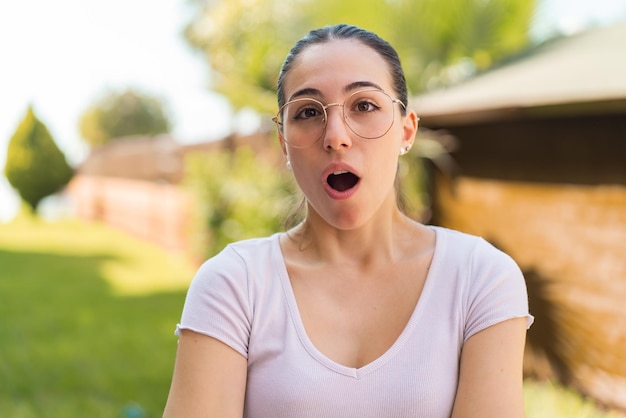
[279, 40, 417, 230]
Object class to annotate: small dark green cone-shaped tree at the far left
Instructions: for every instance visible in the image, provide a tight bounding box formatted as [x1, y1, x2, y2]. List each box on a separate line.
[4, 107, 73, 211]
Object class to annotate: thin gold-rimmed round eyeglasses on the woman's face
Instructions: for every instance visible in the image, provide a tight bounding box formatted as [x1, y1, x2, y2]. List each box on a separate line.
[272, 89, 406, 148]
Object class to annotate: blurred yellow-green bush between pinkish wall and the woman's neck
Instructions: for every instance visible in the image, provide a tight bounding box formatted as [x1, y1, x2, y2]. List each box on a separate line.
[185, 147, 295, 258]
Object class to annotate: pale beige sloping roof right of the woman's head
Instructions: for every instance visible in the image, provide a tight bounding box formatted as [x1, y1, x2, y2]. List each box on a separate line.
[411, 22, 626, 124]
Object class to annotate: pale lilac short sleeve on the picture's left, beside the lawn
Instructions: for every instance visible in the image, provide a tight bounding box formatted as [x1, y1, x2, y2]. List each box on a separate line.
[176, 247, 251, 358]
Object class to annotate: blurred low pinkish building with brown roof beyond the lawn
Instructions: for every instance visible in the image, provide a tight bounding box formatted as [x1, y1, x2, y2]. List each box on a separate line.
[67, 133, 279, 251]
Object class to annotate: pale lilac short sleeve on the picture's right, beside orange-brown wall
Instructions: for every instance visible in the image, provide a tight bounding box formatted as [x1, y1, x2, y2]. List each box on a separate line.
[464, 239, 534, 341]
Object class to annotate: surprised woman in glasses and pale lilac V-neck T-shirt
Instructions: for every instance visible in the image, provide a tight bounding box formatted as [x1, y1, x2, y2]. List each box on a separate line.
[165, 25, 532, 418]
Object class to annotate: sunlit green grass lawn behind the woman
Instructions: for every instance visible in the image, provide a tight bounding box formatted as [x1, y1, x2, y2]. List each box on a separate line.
[0, 217, 619, 418]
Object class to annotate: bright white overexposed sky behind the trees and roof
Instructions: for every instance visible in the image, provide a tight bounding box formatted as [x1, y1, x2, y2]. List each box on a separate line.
[0, 0, 626, 222]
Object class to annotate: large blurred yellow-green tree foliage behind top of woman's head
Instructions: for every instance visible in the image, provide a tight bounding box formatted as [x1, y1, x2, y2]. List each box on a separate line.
[185, 0, 535, 113]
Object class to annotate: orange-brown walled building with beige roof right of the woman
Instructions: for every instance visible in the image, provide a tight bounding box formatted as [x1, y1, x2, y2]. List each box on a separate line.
[412, 23, 626, 409]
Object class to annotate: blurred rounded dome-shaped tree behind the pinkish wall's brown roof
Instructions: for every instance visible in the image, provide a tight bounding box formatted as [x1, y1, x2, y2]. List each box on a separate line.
[79, 89, 171, 146]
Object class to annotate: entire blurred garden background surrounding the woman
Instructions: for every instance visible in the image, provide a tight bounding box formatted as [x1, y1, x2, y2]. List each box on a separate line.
[0, 0, 626, 417]
